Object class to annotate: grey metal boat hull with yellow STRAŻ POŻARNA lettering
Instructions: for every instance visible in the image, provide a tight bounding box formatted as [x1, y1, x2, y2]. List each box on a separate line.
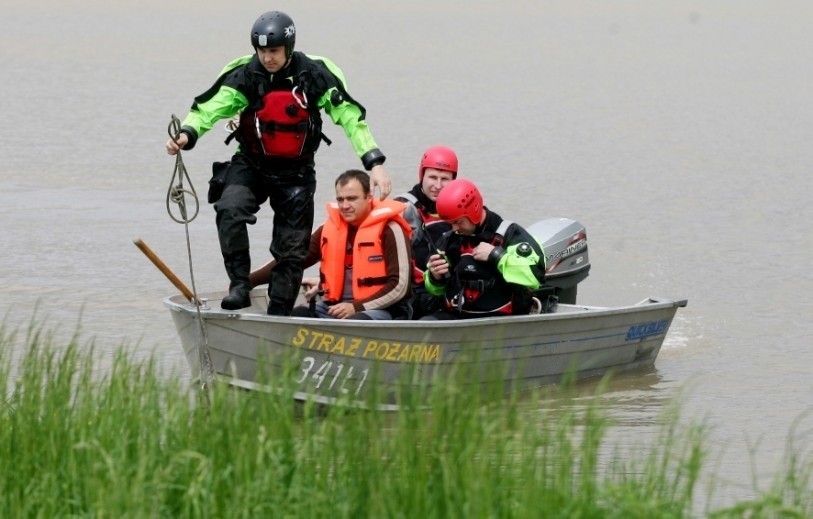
[164, 290, 686, 409]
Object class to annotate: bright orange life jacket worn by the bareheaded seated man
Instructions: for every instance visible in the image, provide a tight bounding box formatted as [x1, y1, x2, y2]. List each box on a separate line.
[319, 199, 412, 301]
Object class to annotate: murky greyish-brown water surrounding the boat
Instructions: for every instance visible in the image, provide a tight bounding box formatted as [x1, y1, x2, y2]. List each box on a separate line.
[0, 0, 813, 504]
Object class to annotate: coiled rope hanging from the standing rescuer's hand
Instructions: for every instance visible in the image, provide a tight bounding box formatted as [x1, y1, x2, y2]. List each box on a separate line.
[167, 114, 214, 403]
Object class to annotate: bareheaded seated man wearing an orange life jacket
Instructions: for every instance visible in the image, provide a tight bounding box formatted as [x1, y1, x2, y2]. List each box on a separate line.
[251, 169, 412, 319]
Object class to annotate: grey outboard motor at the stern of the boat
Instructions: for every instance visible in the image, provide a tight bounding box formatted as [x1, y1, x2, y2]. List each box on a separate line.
[526, 218, 590, 305]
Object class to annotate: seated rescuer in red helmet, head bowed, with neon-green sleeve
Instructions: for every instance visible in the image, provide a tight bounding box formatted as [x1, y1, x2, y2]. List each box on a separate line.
[422, 178, 545, 320]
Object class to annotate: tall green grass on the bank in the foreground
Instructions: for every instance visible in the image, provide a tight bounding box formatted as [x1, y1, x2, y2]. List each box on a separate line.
[0, 322, 813, 518]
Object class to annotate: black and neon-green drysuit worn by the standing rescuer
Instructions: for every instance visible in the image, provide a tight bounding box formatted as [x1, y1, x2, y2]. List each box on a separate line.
[181, 52, 385, 315]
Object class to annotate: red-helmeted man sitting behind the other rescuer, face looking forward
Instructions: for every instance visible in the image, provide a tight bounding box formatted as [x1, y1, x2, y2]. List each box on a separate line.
[395, 145, 458, 319]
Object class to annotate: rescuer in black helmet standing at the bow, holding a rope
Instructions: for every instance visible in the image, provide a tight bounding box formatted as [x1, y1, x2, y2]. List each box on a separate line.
[166, 11, 392, 315]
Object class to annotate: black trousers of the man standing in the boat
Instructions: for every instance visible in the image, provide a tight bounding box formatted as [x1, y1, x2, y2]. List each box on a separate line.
[215, 154, 316, 315]
